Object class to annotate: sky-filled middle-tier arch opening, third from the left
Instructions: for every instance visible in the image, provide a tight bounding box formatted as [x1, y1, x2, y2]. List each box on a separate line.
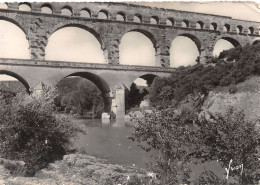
[119, 30, 156, 66]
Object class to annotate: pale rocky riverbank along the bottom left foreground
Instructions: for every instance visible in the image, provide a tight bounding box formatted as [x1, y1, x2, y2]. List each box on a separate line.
[0, 154, 158, 185]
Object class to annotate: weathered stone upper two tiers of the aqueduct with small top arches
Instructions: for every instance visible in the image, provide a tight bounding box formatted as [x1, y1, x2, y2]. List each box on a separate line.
[0, 2, 260, 67]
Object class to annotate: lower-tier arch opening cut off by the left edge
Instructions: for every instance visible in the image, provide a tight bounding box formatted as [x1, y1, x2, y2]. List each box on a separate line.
[0, 70, 30, 94]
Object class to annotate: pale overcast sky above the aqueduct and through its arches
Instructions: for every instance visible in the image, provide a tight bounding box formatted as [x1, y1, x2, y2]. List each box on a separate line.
[0, 2, 260, 84]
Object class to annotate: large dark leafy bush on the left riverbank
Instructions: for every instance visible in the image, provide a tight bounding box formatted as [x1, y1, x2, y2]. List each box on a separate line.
[0, 89, 82, 176]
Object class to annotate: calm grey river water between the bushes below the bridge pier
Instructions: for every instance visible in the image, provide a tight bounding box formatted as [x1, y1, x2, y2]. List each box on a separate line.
[74, 120, 154, 168]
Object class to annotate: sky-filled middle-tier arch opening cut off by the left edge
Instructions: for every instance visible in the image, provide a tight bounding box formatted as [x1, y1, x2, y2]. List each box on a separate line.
[0, 20, 30, 59]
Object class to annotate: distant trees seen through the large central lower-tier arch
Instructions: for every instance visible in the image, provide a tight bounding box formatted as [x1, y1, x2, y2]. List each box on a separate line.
[55, 77, 104, 117]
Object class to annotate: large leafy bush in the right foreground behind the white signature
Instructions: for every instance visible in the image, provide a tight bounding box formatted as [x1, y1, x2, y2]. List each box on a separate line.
[133, 108, 260, 184]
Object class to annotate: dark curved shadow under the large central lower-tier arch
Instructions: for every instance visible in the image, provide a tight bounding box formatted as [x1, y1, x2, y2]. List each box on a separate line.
[65, 72, 112, 113]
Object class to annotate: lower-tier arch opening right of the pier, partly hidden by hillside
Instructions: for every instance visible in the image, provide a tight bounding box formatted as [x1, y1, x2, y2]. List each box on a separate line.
[125, 74, 157, 112]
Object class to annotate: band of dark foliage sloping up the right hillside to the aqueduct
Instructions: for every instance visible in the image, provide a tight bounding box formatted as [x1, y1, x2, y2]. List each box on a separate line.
[149, 44, 260, 106]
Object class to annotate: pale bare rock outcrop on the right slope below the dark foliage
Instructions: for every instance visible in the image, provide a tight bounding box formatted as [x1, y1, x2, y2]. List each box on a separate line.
[201, 77, 260, 121]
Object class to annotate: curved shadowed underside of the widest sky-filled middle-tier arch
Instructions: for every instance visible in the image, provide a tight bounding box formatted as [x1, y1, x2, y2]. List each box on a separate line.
[47, 23, 104, 48]
